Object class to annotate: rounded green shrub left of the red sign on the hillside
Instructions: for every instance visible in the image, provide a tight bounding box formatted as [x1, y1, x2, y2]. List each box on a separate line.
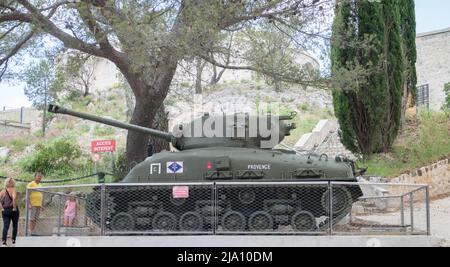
[20, 137, 81, 175]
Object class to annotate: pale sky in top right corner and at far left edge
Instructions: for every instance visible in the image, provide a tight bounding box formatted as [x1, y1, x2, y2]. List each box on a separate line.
[0, 0, 450, 109]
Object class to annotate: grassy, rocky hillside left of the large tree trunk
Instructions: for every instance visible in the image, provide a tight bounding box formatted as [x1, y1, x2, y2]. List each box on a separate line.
[0, 87, 130, 188]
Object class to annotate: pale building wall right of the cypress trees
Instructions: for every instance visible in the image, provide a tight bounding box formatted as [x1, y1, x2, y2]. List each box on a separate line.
[416, 28, 450, 110]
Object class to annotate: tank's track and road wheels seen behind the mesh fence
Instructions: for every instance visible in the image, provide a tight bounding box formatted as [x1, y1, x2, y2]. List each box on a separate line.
[86, 185, 362, 234]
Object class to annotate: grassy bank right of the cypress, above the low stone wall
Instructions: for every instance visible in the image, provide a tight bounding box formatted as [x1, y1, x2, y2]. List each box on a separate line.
[360, 112, 450, 177]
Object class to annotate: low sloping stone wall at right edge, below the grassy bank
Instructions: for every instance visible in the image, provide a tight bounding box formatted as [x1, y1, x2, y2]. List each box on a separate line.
[389, 158, 450, 198]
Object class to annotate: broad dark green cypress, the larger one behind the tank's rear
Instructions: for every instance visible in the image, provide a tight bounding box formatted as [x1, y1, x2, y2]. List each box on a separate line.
[331, 0, 404, 155]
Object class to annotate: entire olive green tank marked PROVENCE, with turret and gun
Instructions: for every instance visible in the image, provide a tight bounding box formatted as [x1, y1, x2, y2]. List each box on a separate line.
[48, 105, 362, 232]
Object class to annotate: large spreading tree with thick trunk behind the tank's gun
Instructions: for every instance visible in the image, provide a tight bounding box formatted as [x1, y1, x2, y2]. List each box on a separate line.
[0, 0, 333, 168]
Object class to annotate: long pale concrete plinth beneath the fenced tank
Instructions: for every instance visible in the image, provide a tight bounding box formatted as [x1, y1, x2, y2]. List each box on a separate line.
[17, 235, 440, 247]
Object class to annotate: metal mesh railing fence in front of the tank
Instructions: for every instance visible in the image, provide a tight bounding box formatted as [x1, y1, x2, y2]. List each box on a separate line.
[25, 181, 430, 236]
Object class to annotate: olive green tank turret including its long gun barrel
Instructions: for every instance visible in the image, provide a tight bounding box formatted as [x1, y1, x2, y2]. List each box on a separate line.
[48, 105, 296, 150]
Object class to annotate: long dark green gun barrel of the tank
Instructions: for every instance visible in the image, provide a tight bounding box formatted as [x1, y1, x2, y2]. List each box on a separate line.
[48, 105, 175, 142]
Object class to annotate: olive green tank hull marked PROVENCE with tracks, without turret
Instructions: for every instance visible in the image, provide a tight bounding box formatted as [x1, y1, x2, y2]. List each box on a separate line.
[88, 147, 362, 233]
